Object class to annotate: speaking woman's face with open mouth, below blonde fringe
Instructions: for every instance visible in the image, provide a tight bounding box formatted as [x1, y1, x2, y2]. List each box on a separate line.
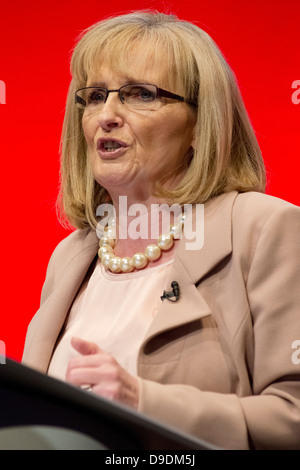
[82, 46, 196, 200]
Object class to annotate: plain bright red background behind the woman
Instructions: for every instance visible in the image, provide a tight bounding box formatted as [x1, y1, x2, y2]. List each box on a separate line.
[0, 0, 300, 360]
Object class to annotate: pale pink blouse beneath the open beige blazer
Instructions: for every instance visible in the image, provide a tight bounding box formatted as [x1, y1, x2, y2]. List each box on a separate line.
[48, 260, 173, 380]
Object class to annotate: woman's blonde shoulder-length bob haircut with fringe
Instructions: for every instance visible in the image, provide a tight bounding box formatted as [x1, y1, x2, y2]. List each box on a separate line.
[57, 11, 265, 229]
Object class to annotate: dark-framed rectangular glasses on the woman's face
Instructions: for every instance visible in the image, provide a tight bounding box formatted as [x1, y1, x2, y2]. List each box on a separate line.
[75, 83, 195, 111]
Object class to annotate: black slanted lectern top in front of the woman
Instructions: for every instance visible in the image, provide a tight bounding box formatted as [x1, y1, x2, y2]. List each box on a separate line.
[0, 359, 216, 451]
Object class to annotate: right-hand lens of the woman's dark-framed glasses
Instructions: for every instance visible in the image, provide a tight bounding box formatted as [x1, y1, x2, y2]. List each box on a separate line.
[120, 84, 159, 109]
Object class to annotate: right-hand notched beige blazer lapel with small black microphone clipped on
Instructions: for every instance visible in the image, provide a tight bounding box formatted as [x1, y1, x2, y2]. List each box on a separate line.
[144, 192, 237, 345]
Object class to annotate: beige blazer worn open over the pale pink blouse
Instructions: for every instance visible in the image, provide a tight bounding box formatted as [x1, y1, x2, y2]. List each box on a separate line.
[23, 192, 300, 449]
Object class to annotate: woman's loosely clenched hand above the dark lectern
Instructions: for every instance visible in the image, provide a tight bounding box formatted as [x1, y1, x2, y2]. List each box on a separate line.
[66, 338, 139, 408]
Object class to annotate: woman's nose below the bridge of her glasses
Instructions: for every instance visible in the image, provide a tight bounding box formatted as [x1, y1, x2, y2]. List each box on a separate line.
[97, 93, 124, 132]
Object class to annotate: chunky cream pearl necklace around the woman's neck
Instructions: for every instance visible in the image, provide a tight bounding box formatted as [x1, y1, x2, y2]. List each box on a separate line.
[98, 215, 185, 273]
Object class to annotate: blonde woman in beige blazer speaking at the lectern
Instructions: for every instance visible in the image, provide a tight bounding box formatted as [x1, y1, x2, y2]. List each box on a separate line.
[23, 12, 300, 449]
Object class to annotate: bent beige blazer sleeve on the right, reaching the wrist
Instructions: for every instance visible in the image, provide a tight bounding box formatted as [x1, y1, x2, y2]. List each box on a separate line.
[139, 204, 300, 449]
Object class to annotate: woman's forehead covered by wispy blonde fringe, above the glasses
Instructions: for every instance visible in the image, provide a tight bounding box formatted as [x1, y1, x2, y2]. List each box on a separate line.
[87, 43, 177, 89]
